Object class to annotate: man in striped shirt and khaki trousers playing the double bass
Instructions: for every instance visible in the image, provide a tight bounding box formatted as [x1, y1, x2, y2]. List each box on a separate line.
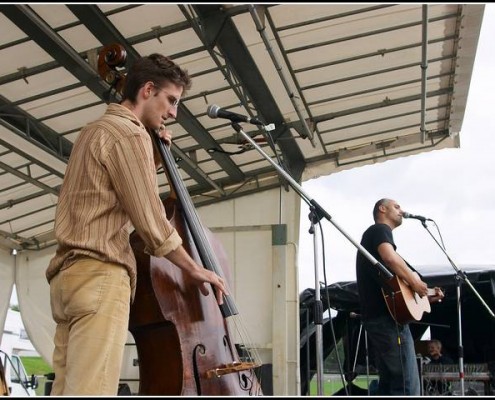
[46, 54, 227, 396]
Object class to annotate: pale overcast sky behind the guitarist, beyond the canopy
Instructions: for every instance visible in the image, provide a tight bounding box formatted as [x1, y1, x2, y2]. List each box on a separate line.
[299, 4, 495, 292]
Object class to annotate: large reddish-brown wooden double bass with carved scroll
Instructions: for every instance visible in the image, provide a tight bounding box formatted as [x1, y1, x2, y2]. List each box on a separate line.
[98, 45, 262, 396]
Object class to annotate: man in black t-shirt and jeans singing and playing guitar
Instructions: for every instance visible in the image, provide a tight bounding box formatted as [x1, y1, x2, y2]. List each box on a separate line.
[356, 198, 443, 396]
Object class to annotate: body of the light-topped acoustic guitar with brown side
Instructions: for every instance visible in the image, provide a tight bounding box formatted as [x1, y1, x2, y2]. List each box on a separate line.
[382, 276, 431, 325]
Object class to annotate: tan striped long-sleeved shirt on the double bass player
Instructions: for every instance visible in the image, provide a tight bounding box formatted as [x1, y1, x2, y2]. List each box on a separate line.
[46, 104, 182, 299]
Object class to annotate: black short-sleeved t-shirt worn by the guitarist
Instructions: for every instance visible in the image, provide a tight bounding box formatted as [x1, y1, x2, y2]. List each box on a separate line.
[356, 224, 397, 319]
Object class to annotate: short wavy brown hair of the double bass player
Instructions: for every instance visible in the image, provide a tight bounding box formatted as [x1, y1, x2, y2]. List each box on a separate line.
[122, 53, 191, 103]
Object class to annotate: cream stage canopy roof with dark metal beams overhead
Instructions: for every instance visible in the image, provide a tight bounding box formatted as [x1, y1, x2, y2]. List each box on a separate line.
[0, 3, 484, 250]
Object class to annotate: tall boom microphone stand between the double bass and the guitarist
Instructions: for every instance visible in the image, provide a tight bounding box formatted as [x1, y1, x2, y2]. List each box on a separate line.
[232, 121, 393, 395]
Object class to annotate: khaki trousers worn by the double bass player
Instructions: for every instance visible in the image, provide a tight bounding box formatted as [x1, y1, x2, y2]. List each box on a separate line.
[50, 258, 131, 396]
